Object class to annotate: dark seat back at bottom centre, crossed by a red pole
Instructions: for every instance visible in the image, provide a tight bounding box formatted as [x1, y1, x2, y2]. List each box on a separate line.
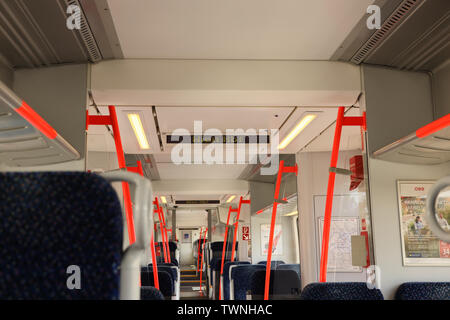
[250, 270, 301, 300]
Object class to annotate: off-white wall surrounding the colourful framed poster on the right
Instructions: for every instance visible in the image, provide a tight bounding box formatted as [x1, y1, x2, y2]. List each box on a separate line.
[369, 159, 450, 299]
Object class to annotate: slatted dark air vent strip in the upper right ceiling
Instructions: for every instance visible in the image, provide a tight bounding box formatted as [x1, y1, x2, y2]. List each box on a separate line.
[351, 0, 423, 64]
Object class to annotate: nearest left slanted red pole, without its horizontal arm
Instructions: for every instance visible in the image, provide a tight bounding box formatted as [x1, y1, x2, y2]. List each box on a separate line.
[108, 106, 136, 245]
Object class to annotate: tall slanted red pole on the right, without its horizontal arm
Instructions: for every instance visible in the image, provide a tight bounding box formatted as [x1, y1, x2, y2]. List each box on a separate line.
[319, 107, 345, 282]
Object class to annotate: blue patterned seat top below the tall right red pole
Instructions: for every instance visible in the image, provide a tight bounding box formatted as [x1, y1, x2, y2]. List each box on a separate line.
[300, 282, 384, 300]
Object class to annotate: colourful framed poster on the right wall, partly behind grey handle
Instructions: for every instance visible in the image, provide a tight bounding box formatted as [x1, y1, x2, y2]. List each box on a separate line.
[398, 181, 450, 266]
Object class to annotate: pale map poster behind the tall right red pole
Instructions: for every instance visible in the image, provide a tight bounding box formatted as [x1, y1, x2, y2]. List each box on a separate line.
[319, 217, 362, 272]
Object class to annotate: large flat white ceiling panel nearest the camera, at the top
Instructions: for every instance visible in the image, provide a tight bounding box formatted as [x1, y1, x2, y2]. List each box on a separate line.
[108, 0, 373, 60]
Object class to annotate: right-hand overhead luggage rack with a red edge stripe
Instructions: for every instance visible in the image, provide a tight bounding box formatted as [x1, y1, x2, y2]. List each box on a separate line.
[373, 114, 450, 165]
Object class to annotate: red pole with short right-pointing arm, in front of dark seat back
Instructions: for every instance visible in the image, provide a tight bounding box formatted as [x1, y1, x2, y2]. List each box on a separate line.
[264, 160, 298, 300]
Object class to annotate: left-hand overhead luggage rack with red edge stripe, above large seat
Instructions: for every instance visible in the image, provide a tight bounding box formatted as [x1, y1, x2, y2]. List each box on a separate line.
[0, 81, 80, 167]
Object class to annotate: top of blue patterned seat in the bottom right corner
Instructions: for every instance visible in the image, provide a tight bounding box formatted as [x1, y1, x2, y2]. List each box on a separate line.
[395, 282, 450, 300]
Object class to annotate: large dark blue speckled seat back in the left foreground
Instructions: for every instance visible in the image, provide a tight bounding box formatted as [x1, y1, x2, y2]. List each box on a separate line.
[0, 172, 123, 299]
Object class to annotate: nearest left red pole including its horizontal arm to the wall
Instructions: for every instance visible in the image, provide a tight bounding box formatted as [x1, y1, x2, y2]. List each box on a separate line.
[86, 106, 136, 245]
